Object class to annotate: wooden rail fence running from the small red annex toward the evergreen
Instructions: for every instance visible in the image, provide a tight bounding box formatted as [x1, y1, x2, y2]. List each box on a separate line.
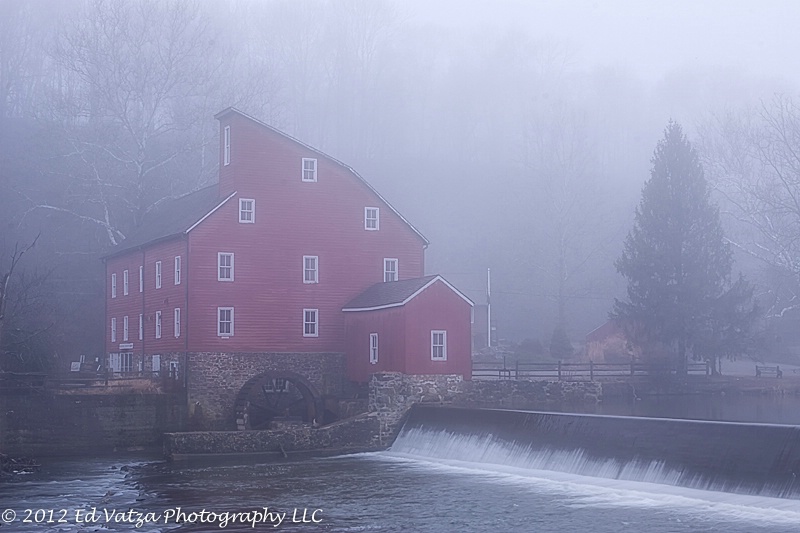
[472, 360, 711, 381]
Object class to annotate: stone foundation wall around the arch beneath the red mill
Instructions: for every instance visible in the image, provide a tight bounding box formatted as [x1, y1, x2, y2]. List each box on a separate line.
[186, 352, 350, 430]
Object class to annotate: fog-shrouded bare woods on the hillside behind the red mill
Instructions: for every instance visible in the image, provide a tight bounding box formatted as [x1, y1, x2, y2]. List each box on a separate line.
[0, 0, 800, 370]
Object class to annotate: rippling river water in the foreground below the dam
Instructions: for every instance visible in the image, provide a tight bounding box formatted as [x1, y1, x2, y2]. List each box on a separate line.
[0, 451, 800, 533]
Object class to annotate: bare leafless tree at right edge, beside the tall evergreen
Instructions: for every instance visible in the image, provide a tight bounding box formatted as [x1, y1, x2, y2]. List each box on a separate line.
[701, 95, 800, 316]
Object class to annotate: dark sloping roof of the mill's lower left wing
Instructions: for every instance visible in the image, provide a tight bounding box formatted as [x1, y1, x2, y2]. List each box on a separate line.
[104, 183, 236, 258]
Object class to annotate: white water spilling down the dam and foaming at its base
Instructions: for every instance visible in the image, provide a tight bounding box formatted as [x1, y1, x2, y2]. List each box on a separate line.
[376, 428, 800, 527]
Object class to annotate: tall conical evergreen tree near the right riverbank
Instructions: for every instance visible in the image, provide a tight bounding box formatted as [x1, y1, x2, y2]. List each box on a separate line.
[611, 122, 755, 372]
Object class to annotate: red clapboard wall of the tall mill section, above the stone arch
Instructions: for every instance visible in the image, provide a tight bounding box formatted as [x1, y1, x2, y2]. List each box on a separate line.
[188, 113, 424, 352]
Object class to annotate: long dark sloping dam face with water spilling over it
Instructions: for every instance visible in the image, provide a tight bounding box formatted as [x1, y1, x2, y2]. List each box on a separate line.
[391, 405, 800, 500]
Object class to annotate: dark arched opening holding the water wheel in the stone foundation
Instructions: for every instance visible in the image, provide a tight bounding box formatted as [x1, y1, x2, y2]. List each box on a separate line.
[235, 371, 323, 430]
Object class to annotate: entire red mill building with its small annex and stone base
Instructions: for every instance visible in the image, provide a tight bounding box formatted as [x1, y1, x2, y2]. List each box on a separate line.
[105, 108, 472, 429]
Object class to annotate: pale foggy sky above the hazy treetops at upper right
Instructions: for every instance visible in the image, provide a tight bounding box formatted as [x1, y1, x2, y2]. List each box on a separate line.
[403, 0, 800, 84]
